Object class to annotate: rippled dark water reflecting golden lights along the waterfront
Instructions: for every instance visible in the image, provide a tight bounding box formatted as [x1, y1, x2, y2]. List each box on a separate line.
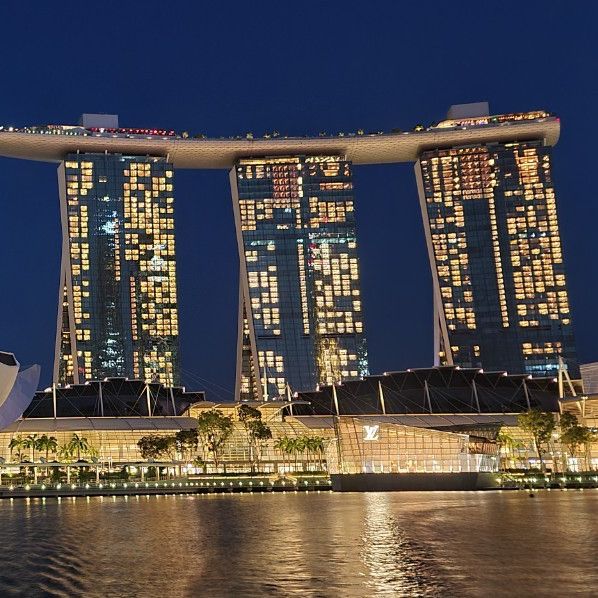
[0, 490, 598, 598]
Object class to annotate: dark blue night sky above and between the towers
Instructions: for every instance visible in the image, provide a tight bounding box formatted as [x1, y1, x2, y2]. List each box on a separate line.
[0, 0, 598, 399]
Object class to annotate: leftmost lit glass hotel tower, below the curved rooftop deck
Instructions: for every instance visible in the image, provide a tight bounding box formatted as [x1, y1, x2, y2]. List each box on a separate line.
[54, 154, 179, 385]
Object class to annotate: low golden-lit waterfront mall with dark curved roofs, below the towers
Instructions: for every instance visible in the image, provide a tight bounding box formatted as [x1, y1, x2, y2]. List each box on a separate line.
[0, 367, 598, 490]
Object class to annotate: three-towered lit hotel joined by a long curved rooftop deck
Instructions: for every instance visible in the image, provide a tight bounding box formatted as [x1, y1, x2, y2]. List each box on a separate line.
[0, 102, 579, 400]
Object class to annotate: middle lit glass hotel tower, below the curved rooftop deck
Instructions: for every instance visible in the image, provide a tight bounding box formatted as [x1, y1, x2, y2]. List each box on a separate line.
[231, 156, 368, 400]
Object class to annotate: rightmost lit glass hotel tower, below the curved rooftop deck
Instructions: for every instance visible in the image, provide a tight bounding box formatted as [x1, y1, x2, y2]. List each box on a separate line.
[416, 141, 579, 377]
